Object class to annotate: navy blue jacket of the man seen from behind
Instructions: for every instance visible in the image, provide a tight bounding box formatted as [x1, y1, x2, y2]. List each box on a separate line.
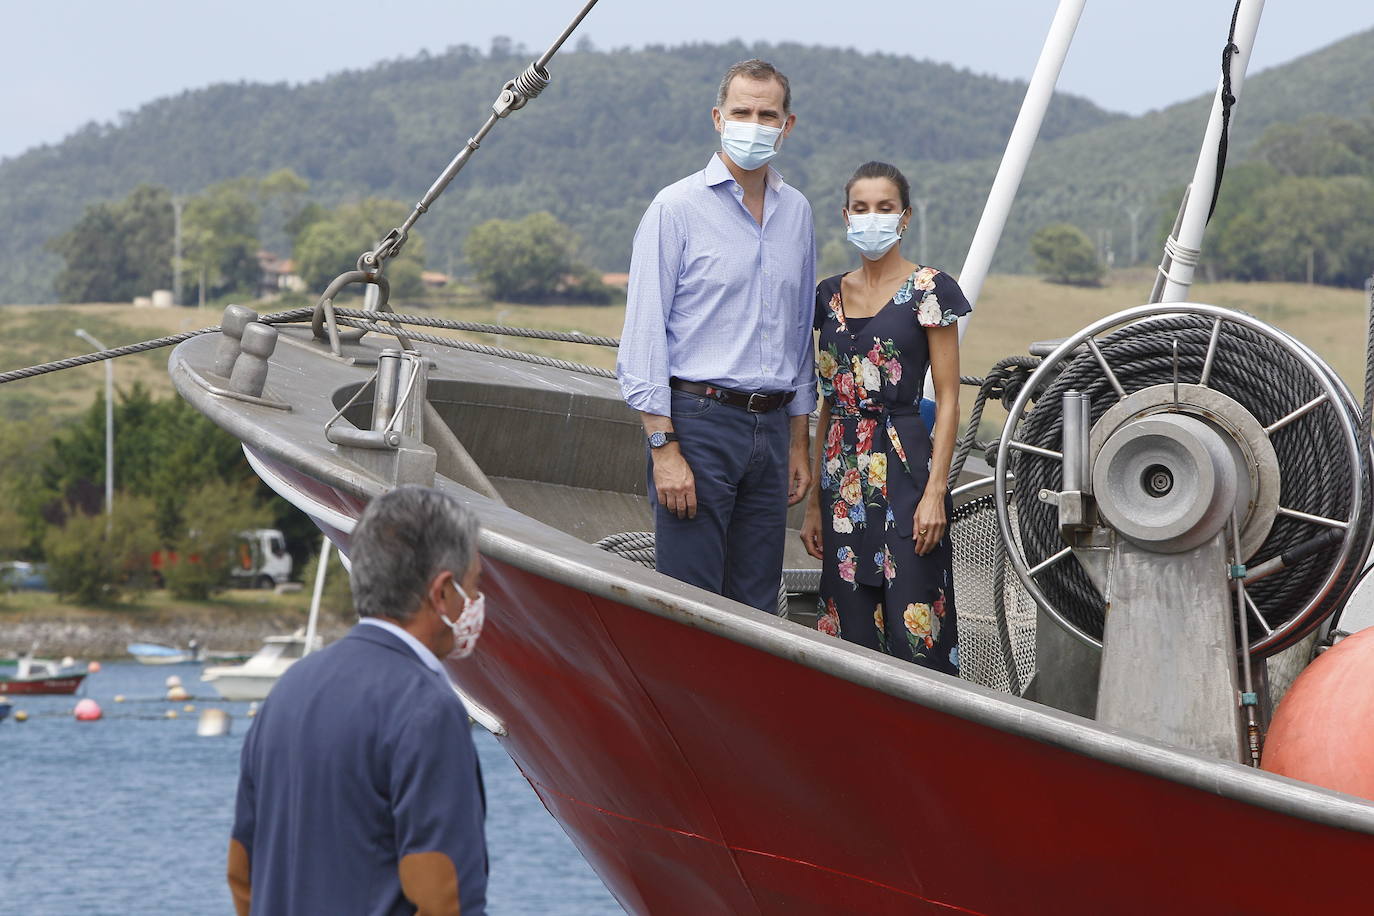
[232, 625, 486, 916]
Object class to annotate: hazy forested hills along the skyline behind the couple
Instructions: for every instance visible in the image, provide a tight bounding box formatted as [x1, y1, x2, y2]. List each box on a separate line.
[0, 33, 1374, 302]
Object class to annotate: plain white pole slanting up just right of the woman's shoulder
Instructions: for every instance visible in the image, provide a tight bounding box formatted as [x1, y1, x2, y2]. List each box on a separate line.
[956, 0, 1087, 329]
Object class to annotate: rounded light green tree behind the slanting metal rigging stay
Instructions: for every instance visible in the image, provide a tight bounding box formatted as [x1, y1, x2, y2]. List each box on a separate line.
[291, 198, 425, 297]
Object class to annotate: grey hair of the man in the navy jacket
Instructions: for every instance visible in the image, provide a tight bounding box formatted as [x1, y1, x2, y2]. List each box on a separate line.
[349, 486, 478, 623]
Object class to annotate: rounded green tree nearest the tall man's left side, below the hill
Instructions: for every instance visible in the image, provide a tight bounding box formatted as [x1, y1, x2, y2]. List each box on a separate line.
[466, 211, 585, 302]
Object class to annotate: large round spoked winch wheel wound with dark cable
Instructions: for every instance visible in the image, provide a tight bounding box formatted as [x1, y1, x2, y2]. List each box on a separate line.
[992, 302, 1374, 656]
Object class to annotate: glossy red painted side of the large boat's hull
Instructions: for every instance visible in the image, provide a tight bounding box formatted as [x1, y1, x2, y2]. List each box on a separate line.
[451, 560, 1374, 916]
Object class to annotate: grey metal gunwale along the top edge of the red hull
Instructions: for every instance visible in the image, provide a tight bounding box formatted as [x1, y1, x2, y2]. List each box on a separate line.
[168, 338, 1374, 834]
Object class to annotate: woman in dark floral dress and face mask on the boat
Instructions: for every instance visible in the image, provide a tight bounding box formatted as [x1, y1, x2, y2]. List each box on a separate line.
[801, 162, 971, 674]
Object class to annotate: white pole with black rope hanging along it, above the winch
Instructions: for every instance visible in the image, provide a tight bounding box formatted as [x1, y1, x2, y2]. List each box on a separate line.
[1160, 0, 1264, 302]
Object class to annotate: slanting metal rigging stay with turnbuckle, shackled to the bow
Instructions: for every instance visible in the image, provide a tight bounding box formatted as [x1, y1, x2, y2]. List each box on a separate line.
[313, 0, 596, 354]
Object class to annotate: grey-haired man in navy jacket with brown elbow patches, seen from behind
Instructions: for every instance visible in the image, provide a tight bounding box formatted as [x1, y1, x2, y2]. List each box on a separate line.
[228, 486, 486, 916]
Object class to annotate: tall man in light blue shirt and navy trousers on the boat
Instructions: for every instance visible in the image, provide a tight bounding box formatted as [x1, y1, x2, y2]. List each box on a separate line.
[617, 60, 816, 612]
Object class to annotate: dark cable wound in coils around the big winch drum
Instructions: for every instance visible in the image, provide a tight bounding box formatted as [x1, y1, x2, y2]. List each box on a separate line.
[1011, 316, 1370, 637]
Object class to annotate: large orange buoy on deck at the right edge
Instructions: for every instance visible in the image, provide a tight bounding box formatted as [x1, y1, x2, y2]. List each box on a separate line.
[1261, 626, 1374, 801]
